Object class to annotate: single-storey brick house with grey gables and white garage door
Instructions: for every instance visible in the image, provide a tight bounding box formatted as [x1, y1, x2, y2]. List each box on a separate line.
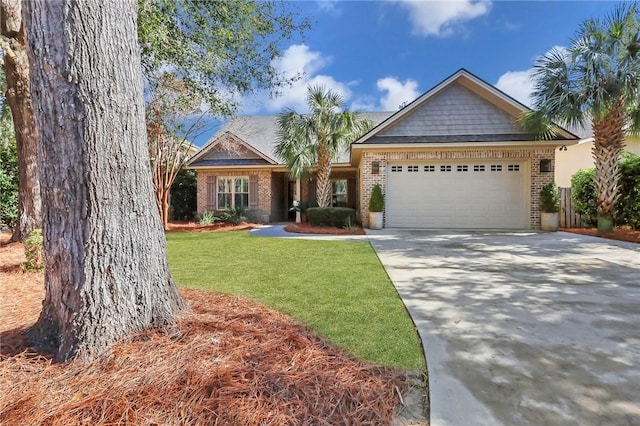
[189, 69, 578, 229]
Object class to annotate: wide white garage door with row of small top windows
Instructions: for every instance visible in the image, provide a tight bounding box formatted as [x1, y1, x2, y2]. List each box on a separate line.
[385, 160, 528, 229]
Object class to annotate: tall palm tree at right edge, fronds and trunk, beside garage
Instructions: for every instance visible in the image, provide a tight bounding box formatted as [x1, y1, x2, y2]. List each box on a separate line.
[525, 3, 640, 234]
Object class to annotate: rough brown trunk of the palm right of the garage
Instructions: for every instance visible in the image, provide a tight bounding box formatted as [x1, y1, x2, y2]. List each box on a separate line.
[592, 102, 625, 235]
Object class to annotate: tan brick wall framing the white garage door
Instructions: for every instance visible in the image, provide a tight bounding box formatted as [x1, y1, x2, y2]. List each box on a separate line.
[359, 147, 555, 229]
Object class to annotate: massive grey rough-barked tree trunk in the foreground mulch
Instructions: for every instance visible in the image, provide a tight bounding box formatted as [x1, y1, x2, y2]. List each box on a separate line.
[24, 0, 185, 361]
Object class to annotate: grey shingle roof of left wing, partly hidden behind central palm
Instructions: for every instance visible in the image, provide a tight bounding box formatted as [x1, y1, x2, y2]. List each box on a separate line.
[191, 111, 394, 165]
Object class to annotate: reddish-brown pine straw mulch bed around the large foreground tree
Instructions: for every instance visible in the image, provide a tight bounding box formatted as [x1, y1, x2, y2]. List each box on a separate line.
[0, 238, 407, 425]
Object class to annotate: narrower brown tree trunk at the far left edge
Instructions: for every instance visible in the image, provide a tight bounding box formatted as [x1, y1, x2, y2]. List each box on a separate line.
[0, 0, 42, 241]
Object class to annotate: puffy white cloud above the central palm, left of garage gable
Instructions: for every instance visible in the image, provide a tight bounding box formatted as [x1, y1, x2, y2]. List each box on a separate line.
[241, 44, 351, 114]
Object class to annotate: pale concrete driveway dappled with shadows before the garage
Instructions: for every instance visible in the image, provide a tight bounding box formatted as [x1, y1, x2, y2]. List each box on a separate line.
[369, 229, 640, 426]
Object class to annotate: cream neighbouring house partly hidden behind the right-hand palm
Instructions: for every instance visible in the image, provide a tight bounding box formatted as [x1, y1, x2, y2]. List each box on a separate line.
[555, 136, 640, 188]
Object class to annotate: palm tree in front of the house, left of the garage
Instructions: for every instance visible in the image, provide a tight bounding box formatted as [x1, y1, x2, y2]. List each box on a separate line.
[276, 86, 373, 207]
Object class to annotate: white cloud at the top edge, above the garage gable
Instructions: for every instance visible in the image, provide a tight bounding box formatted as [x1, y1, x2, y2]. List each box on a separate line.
[397, 0, 491, 36]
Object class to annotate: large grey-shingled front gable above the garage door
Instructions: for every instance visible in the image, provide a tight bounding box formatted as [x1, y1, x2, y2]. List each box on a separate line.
[352, 68, 578, 148]
